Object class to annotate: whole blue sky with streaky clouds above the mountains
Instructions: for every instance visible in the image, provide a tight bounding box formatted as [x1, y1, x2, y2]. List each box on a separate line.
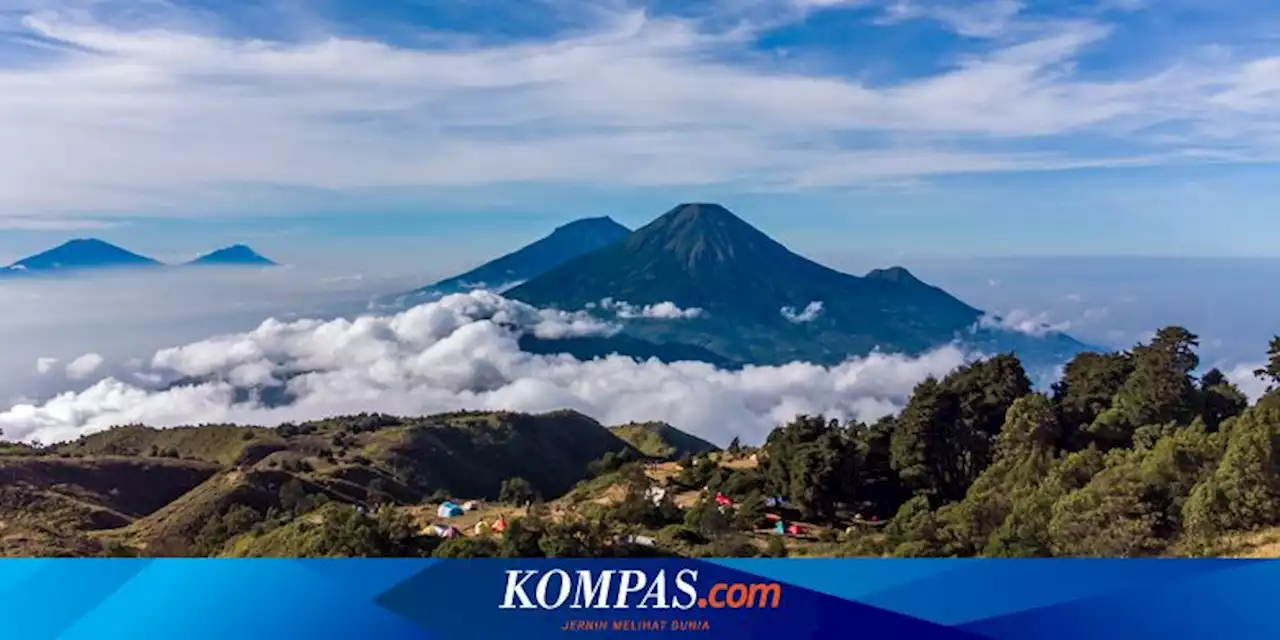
[0, 0, 1280, 270]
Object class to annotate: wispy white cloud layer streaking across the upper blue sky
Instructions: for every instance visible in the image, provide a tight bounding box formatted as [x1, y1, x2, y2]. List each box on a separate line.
[0, 0, 1280, 215]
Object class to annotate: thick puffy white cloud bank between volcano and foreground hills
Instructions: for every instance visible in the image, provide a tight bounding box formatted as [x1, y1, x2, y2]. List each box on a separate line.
[0, 292, 965, 442]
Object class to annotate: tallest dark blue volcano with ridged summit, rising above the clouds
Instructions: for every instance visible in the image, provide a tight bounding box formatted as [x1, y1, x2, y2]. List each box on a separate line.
[504, 204, 1084, 365]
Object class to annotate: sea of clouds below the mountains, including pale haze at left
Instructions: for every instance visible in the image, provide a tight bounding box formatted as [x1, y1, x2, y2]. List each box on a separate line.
[0, 261, 1263, 444]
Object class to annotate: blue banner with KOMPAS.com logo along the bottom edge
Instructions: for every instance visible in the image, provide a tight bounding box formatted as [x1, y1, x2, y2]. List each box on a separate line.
[0, 559, 1280, 640]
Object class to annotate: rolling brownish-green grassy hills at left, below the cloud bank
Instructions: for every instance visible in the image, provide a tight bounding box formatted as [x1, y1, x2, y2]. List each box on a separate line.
[0, 411, 628, 556]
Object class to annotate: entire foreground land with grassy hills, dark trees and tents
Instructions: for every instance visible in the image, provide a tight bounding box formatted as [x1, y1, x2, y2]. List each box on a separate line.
[0, 328, 1280, 557]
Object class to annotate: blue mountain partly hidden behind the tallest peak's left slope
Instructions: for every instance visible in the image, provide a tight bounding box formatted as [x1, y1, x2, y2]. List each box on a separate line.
[393, 216, 631, 308]
